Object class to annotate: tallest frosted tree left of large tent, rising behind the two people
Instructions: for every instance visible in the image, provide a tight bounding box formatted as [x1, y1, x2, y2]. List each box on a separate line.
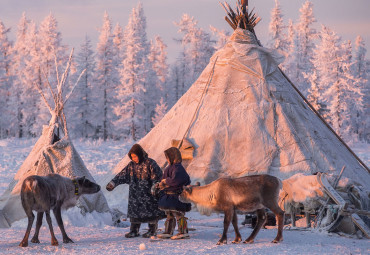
[115, 3, 150, 141]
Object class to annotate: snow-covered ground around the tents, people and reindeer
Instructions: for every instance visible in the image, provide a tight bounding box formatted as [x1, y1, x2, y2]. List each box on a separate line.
[0, 139, 370, 254]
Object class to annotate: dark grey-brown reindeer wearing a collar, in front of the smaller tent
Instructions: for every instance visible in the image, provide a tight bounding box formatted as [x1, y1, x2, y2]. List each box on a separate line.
[19, 174, 100, 247]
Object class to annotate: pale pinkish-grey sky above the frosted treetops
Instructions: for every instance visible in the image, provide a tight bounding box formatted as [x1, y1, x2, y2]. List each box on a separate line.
[0, 0, 370, 62]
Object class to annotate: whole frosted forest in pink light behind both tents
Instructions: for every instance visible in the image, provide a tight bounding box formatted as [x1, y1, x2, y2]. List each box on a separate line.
[0, 0, 370, 142]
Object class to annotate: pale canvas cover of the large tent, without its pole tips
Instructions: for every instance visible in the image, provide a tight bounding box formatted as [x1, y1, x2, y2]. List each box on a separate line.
[102, 28, 370, 207]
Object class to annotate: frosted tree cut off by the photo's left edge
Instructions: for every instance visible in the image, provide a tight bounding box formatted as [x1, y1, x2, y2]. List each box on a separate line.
[0, 20, 12, 138]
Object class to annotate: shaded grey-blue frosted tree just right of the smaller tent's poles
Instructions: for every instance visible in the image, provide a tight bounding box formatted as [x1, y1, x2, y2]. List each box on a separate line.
[66, 36, 98, 138]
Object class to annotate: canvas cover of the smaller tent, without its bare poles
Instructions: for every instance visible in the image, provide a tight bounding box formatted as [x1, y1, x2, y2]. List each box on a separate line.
[0, 124, 109, 228]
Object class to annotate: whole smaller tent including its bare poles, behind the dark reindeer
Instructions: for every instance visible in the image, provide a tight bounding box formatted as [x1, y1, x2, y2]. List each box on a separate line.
[0, 51, 110, 228]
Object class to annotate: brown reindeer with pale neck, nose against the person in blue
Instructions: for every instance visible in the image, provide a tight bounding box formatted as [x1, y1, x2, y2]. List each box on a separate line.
[179, 175, 284, 245]
